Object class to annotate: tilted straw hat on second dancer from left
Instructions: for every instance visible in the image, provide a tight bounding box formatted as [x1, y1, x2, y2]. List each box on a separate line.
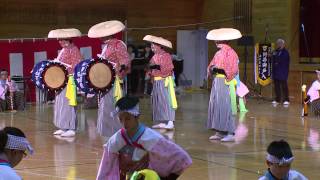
[88, 20, 125, 38]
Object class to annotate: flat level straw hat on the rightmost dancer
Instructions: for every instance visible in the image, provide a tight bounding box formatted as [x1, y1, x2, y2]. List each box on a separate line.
[207, 28, 242, 41]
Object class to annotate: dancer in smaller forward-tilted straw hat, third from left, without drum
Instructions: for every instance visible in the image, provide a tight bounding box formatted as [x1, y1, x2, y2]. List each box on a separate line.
[143, 35, 178, 130]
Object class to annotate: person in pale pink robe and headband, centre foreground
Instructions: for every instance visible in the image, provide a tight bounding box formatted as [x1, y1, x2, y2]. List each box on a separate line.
[96, 96, 192, 180]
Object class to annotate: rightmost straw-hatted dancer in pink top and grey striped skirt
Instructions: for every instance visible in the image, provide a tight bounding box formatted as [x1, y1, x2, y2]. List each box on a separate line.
[207, 28, 241, 142]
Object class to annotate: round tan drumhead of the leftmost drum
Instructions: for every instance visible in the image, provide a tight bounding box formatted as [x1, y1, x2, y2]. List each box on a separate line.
[43, 64, 67, 90]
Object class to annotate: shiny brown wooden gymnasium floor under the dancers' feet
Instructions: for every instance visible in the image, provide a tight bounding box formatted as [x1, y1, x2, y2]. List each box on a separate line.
[0, 93, 320, 180]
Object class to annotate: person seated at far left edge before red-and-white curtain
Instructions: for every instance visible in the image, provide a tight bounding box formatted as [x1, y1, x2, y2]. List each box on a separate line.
[0, 69, 24, 111]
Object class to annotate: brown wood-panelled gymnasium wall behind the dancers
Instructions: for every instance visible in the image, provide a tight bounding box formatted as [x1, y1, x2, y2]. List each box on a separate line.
[0, 0, 308, 102]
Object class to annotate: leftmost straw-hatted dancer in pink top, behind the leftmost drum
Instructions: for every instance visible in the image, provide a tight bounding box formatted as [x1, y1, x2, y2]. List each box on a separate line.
[48, 29, 82, 137]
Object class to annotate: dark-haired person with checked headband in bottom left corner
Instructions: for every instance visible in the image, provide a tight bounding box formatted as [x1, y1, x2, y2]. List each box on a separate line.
[0, 127, 33, 180]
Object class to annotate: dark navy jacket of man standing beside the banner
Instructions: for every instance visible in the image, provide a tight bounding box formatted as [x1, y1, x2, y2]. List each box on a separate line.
[272, 48, 290, 81]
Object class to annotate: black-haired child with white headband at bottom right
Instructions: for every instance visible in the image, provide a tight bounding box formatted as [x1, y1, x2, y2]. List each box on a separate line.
[259, 140, 307, 180]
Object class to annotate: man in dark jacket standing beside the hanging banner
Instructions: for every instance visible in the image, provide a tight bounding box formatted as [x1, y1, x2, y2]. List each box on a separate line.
[272, 39, 290, 105]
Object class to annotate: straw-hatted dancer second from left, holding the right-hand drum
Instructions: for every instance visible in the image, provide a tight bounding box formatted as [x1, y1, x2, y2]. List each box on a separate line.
[88, 20, 130, 137]
